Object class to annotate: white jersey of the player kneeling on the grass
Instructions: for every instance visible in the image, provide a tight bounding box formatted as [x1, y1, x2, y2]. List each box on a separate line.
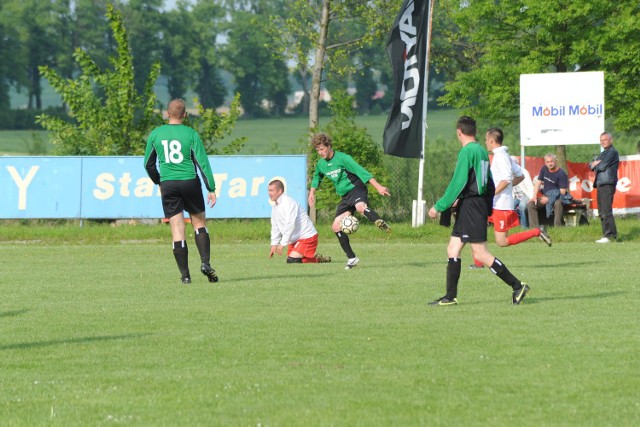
[271, 193, 318, 246]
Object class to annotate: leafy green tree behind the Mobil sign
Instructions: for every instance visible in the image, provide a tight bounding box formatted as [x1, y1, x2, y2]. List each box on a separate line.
[439, 0, 640, 166]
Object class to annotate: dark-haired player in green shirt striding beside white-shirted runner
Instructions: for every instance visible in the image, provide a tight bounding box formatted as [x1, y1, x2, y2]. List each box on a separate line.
[429, 116, 529, 306]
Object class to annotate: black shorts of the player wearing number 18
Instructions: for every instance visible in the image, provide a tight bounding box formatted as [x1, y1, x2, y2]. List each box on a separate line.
[160, 177, 204, 218]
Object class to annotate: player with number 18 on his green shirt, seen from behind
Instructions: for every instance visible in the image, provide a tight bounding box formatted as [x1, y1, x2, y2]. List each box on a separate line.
[144, 99, 218, 284]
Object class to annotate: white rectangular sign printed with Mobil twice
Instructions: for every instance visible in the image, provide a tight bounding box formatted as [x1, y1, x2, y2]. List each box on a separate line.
[520, 71, 604, 146]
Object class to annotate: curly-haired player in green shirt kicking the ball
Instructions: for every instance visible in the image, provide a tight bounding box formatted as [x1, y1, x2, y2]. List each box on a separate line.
[309, 133, 391, 270]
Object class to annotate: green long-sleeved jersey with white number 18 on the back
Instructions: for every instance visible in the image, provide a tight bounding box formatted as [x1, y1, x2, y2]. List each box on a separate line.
[144, 124, 216, 192]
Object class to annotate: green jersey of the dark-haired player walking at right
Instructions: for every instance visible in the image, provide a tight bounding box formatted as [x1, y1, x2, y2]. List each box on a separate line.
[434, 142, 493, 212]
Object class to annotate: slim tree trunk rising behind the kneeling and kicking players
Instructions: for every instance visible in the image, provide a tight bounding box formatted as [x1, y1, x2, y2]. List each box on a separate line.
[307, 0, 331, 223]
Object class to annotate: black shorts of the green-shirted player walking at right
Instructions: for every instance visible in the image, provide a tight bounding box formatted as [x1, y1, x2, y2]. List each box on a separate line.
[451, 197, 489, 243]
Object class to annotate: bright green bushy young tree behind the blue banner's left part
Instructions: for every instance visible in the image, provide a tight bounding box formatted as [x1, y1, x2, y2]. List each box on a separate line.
[37, 5, 160, 155]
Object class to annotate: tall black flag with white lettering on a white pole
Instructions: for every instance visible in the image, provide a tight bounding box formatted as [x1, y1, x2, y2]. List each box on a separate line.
[383, 0, 429, 158]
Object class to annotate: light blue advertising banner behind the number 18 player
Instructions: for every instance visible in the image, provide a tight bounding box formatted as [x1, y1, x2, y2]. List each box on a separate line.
[0, 155, 307, 219]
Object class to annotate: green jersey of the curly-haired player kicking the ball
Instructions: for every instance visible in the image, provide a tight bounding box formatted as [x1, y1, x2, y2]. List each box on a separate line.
[311, 151, 373, 197]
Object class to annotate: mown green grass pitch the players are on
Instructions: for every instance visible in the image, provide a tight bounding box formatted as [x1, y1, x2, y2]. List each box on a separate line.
[0, 219, 640, 426]
